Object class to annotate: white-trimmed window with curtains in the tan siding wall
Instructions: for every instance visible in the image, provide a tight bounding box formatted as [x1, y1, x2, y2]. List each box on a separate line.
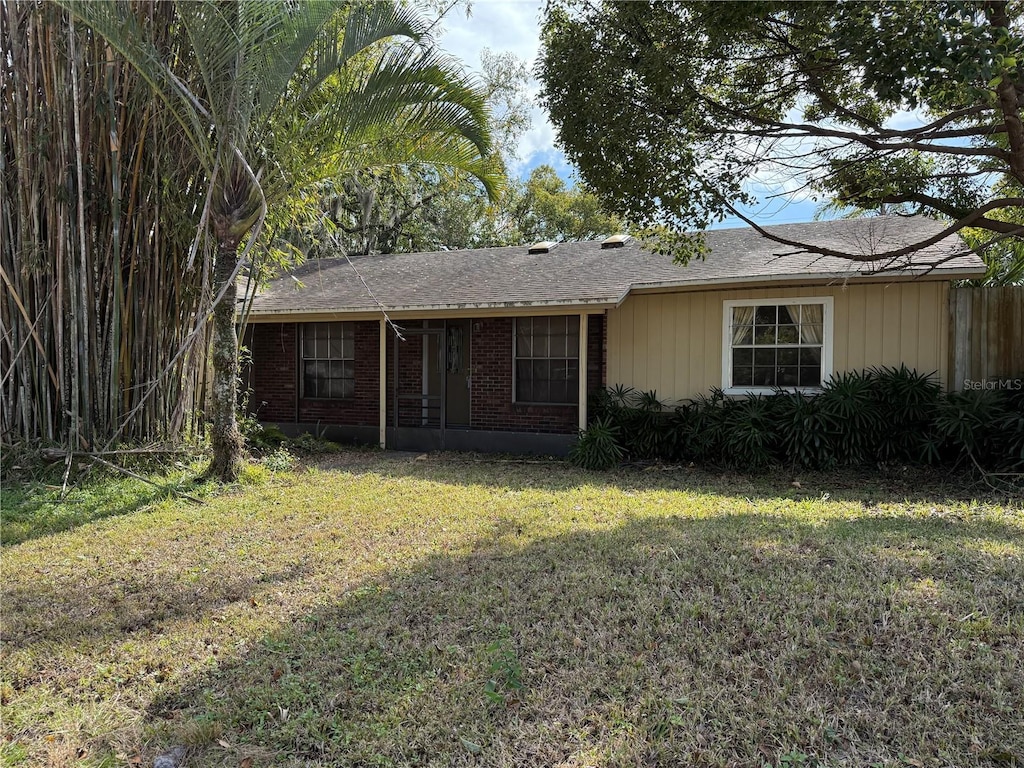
[722, 297, 833, 394]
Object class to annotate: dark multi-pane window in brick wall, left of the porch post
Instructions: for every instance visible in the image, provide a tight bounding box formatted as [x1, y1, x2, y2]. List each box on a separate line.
[302, 323, 355, 399]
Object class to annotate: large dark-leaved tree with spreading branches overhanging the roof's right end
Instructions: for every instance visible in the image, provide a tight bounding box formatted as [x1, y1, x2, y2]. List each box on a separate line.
[539, 0, 1024, 270]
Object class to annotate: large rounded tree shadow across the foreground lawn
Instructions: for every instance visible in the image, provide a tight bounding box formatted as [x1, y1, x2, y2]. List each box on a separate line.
[146, 512, 1024, 768]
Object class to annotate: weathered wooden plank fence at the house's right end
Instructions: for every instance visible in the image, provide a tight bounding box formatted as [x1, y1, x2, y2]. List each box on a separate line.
[949, 286, 1024, 390]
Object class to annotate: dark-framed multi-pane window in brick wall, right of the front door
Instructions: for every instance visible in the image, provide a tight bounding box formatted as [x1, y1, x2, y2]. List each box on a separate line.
[512, 315, 580, 404]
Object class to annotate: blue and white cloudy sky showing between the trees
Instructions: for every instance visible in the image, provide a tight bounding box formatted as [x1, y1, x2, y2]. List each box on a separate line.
[438, 0, 817, 226]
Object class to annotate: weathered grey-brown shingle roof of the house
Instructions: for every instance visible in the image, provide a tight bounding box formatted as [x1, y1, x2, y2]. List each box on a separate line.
[245, 216, 984, 314]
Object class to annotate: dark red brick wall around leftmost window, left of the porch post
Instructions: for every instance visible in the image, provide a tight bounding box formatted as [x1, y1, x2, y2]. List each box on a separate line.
[248, 321, 380, 426]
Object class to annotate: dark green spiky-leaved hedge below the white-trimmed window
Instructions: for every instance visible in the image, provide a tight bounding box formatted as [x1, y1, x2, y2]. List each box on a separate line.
[570, 367, 1024, 472]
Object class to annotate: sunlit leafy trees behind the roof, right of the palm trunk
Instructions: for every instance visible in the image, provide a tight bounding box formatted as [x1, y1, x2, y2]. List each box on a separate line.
[292, 40, 623, 257]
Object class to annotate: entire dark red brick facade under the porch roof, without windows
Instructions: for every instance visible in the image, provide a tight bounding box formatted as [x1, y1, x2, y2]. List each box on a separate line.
[247, 315, 607, 434]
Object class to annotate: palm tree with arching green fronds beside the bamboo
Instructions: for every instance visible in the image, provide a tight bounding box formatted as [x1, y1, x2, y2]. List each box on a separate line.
[60, 0, 500, 481]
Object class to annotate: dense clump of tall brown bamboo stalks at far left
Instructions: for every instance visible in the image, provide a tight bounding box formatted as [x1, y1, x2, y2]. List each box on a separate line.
[0, 0, 208, 446]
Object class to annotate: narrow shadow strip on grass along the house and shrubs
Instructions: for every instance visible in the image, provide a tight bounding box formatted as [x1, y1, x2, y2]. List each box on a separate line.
[315, 451, 1024, 511]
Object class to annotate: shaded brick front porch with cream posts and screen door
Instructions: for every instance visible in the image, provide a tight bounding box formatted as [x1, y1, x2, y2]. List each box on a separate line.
[247, 313, 605, 455]
